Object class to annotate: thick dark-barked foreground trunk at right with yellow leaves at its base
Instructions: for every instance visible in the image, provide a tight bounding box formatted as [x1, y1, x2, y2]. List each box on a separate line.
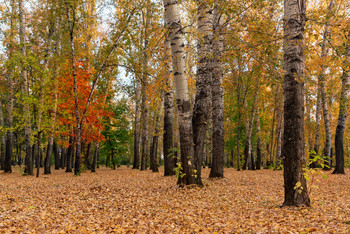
[282, 0, 310, 206]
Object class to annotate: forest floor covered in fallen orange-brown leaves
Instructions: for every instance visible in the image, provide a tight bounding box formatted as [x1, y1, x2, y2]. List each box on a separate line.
[0, 167, 350, 233]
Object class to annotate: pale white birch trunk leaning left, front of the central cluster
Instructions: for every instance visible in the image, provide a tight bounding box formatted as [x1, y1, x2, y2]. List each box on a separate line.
[163, 0, 198, 185]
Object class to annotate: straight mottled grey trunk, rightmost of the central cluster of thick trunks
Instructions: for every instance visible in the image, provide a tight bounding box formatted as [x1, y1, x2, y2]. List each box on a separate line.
[209, 5, 225, 177]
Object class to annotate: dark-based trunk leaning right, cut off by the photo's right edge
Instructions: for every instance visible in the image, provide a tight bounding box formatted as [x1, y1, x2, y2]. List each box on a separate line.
[333, 44, 350, 174]
